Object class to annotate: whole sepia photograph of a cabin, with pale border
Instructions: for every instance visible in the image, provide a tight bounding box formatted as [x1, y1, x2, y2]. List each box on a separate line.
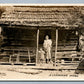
[0, 4, 84, 81]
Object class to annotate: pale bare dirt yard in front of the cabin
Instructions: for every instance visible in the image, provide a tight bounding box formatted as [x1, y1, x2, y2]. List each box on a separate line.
[0, 65, 84, 80]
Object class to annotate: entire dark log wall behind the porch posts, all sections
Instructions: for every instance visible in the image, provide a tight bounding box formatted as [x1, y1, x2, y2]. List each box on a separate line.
[2, 28, 78, 62]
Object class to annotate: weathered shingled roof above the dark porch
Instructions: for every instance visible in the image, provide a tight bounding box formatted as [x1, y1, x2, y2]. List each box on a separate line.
[0, 6, 84, 28]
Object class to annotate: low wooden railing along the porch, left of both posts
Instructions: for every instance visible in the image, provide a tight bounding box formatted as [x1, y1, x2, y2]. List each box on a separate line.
[1, 47, 36, 63]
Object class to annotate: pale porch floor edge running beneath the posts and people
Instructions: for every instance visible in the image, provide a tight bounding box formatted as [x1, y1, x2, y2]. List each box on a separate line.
[0, 62, 79, 70]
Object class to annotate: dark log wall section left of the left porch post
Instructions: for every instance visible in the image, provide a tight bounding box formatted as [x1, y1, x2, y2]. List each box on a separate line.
[2, 28, 37, 62]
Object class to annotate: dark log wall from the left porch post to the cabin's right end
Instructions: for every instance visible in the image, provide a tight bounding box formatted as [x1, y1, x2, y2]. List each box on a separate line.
[36, 29, 78, 61]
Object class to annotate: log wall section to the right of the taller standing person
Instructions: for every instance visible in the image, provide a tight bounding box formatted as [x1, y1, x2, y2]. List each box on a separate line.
[52, 30, 78, 61]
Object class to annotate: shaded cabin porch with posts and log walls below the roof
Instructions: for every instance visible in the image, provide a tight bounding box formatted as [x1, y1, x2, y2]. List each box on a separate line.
[0, 27, 81, 69]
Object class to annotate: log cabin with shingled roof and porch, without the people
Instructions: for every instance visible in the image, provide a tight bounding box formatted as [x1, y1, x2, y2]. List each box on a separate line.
[0, 5, 84, 66]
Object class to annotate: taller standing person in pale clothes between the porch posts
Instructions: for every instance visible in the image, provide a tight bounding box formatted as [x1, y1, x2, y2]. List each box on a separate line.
[43, 35, 52, 63]
